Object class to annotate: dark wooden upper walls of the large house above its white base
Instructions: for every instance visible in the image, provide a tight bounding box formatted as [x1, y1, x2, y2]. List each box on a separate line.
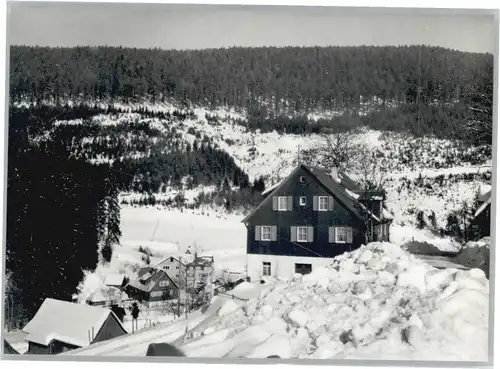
[244, 165, 390, 257]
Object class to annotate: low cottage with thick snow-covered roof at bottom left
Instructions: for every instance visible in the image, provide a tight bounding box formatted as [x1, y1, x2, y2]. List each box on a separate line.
[23, 298, 127, 355]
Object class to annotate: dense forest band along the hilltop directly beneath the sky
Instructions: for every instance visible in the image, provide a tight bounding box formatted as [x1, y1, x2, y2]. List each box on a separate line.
[10, 46, 493, 144]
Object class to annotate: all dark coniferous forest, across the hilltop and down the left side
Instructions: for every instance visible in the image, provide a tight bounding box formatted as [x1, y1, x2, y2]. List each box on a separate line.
[7, 46, 493, 321]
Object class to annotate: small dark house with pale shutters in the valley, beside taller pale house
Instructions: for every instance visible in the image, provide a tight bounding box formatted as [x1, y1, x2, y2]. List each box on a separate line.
[125, 267, 179, 307]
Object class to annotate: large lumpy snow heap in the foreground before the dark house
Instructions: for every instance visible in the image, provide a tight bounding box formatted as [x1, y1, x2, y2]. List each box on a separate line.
[177, 243, 489, 361]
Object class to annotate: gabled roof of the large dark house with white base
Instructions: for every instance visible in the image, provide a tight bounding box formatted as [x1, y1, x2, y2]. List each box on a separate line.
[242, 164, 388, 222]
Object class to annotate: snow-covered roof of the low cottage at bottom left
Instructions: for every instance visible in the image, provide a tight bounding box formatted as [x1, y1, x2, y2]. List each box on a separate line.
[23, 298, 126, 347]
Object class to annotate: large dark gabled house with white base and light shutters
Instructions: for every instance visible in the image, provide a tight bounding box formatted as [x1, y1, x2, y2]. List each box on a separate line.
[243, 164, 392, 279]
